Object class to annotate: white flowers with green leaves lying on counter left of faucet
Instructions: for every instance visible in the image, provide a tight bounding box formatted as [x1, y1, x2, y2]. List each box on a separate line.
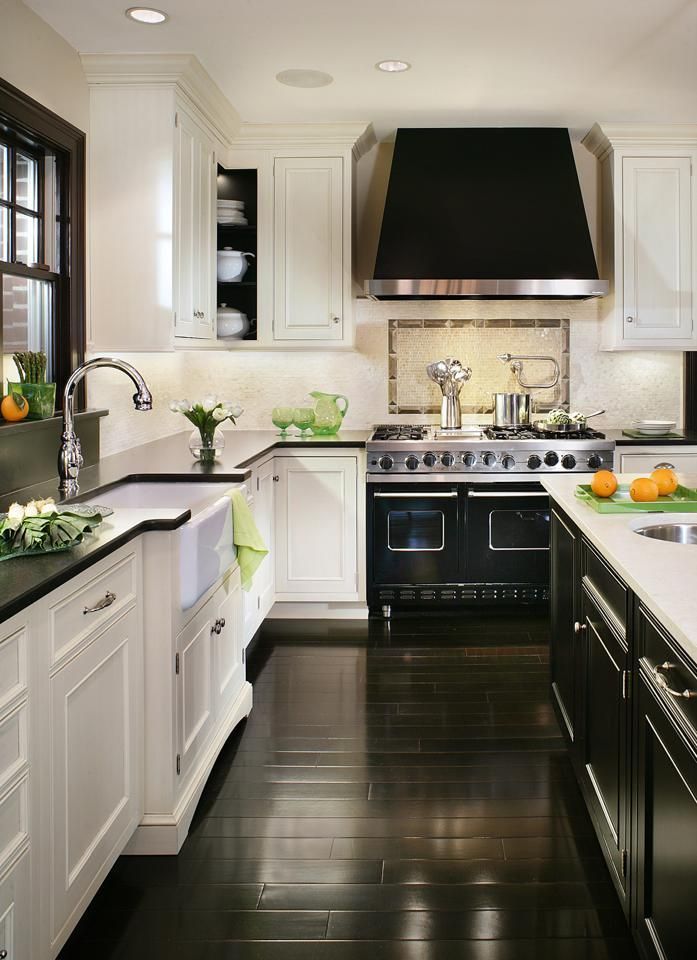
[0, 497, 102, 560]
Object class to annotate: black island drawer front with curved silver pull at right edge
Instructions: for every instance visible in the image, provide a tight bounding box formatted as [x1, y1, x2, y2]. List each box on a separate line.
[637, 605, 697, 743]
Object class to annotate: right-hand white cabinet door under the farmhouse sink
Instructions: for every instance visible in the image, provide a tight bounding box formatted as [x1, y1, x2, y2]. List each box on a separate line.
[212, 570, 244, 719]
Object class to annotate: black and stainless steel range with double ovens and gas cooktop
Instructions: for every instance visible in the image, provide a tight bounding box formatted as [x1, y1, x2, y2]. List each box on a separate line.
[367, 425, 615, 616]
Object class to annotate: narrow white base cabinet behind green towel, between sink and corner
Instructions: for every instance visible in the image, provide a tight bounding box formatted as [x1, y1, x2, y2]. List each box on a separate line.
[242, 460, 276, 646]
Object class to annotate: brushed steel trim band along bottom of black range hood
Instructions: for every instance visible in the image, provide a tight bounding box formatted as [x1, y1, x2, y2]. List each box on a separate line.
[365, 279, 609, 300]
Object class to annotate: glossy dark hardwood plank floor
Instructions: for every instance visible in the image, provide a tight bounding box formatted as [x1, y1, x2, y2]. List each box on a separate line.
[60, 612, 636, 960]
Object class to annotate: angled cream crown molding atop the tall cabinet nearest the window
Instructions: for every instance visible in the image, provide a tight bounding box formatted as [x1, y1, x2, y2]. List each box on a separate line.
[80, 53, 240, 146]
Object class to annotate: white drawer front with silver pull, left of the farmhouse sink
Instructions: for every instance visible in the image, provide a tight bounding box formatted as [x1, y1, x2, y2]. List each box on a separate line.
[49, 553, 138, 666]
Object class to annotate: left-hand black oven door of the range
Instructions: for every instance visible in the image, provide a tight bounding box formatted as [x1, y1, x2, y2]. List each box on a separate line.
[368, 484, 462, 585]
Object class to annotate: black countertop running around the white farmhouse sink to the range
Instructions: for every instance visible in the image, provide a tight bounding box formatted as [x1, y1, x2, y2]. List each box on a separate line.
[0, 430, 369, 622]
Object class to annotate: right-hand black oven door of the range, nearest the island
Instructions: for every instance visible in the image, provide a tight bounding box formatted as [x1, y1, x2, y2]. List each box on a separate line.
[467, 483, 550, 584]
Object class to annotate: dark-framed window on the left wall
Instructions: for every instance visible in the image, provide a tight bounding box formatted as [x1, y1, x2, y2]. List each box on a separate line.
[0, 81, 84, 408]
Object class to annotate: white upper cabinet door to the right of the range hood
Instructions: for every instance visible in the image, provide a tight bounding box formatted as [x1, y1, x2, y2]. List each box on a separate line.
[622, 157, 693, 341]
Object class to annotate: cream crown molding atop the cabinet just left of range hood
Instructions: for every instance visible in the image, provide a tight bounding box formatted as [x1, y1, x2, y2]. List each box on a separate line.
[233, 120, 377, 160]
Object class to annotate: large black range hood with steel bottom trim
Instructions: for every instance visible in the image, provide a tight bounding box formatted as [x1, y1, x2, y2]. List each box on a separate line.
[366, 127, 608, 300]
